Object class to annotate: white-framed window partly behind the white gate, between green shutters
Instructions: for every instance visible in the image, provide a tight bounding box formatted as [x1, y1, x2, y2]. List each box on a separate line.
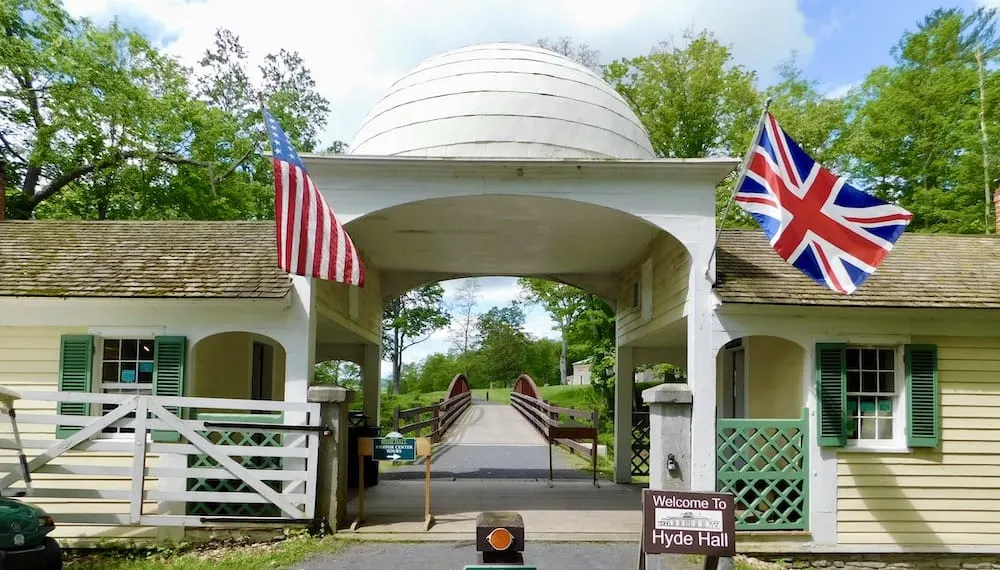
[97, 337, 154, 434]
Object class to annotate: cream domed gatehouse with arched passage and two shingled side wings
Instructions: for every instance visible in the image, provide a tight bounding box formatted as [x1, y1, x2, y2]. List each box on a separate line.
[0, 44, 1000, 555]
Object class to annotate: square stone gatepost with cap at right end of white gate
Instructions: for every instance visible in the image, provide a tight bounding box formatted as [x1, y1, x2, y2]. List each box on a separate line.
[309, 386, 354, 532]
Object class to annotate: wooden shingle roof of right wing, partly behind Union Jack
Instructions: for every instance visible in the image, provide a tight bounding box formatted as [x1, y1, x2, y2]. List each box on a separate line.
[715, 230, 1000, 309]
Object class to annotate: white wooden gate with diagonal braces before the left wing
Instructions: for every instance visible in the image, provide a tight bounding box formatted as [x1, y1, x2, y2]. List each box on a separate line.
[0, 391, 323, 527]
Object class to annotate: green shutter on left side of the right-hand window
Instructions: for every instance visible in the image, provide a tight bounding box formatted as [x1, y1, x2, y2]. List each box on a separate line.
[816, 343, 847, 447]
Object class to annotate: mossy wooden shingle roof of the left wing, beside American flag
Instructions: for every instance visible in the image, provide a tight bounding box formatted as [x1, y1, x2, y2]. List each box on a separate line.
[0, 220, 291, 299]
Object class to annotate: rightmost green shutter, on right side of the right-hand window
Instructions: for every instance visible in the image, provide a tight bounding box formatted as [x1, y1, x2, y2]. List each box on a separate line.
[906, 344, 941, 447]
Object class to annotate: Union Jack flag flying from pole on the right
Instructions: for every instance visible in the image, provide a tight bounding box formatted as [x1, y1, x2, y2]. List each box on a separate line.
[735, 113, 913, 294]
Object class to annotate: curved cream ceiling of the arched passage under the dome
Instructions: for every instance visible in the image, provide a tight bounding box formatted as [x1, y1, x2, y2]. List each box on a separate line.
[347, 195, 660, 275]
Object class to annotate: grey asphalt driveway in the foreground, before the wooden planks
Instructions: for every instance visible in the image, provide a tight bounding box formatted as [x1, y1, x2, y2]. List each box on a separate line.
[294, 541, 701, 570]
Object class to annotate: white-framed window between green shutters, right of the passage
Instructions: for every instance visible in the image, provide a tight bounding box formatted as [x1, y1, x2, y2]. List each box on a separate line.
[844, 345, 906, 450]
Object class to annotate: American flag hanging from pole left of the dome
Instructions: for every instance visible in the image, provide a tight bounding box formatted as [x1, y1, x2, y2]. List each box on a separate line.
[264, 109, 365, 287]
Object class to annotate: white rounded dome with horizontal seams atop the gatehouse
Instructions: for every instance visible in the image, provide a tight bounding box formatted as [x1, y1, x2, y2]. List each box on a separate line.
[350, 43, 654, 159]
